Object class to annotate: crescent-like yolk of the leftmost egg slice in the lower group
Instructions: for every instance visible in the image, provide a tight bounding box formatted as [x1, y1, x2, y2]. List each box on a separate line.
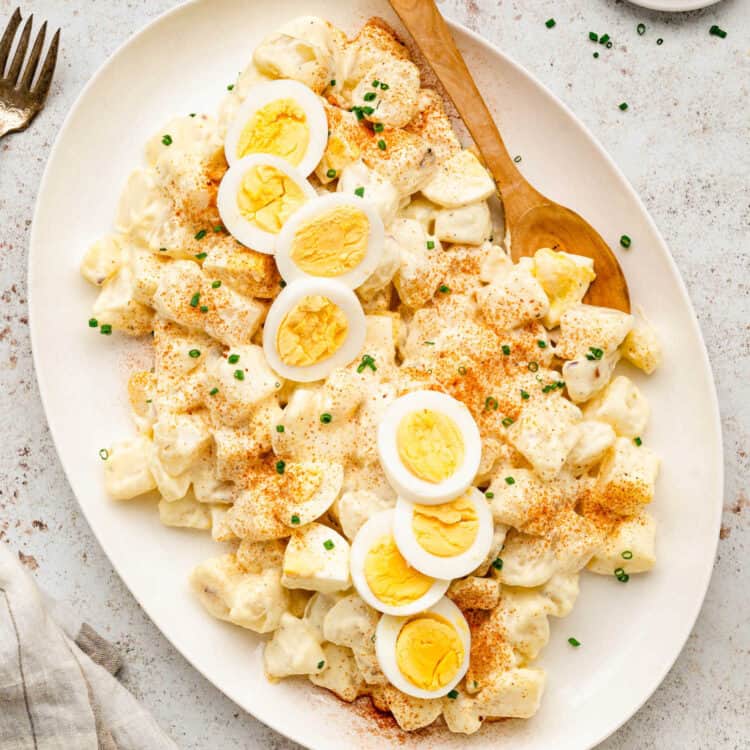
[364, 536, 434, 607]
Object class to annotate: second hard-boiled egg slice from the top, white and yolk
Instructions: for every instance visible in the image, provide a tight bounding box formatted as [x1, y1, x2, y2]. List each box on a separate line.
[216, 154, 316, 255]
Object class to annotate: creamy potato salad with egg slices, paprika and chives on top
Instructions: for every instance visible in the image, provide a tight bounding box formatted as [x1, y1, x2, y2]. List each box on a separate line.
[81, 17, 660, 734]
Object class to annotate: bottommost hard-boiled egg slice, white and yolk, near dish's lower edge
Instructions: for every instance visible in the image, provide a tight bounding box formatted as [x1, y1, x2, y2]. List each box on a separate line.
[375, 598, 471, 698]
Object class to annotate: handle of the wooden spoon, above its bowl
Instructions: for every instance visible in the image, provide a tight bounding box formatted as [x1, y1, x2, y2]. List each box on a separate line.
[390, 0, 539, 218]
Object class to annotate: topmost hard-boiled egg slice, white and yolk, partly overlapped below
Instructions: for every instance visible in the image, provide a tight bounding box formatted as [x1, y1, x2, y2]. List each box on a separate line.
[224, 81, 328, 176]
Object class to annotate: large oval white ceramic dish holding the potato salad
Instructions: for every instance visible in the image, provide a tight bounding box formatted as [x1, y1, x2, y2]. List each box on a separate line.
[29, 0, 722, 750]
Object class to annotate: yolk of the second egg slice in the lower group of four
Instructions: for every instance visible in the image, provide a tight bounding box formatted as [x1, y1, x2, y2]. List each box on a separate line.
[411, 496, 479, 557]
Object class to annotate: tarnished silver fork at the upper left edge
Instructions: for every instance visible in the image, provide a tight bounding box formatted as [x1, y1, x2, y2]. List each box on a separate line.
[0, 8, 60, 138]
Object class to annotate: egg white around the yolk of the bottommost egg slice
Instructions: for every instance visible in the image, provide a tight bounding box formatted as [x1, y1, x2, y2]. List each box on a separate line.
[375, 597, 471, 698]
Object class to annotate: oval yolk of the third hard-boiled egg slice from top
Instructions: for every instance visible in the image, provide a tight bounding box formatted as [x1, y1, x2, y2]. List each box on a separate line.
[289, 206, 370, 278]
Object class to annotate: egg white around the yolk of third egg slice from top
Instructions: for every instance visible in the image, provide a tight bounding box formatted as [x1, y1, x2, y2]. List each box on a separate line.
[276, 193, 385, 289]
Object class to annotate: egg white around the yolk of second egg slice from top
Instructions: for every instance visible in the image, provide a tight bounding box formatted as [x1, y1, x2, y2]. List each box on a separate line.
[216, 154, 317, 255]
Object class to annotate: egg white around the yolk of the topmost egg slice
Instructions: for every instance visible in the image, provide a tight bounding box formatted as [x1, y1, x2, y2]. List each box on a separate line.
[224, 79, 328, 176]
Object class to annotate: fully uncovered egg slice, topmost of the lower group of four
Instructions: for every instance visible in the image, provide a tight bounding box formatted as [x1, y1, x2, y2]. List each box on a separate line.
[378, 391, 482, 505]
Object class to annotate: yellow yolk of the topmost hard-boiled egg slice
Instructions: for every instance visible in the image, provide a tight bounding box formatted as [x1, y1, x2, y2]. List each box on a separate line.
[237, 99, 310, 167]
